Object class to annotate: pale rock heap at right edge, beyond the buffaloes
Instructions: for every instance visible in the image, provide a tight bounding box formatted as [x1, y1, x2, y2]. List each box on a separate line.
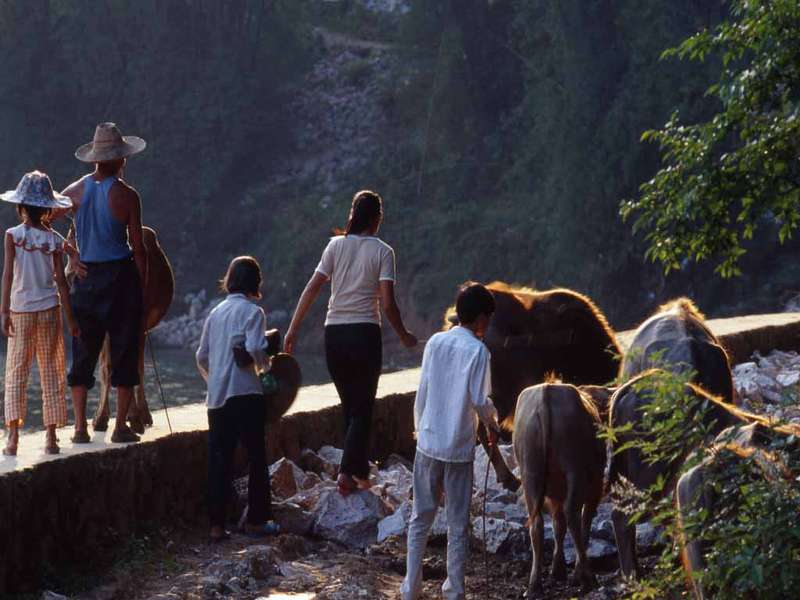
[733, 350, 800, 424]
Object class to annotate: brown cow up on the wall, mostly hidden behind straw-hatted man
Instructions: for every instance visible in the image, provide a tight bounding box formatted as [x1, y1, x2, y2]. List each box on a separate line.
[92, 227, 175, 433]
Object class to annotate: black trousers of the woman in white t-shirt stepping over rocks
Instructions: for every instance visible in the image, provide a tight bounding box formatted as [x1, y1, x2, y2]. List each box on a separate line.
[325, 323, 383, 479]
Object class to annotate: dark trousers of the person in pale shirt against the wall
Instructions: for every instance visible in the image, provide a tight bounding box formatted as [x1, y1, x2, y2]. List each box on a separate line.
[208, 394, 272, 527]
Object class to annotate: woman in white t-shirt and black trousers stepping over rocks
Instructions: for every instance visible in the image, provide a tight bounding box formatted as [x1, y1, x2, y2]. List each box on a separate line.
[284, 191, 417, 494]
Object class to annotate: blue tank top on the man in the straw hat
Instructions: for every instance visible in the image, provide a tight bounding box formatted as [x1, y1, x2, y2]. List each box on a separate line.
[75, 175, 133, 262]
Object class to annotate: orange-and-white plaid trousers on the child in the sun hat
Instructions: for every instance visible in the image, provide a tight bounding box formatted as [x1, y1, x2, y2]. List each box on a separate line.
[5, 306, 67, 427]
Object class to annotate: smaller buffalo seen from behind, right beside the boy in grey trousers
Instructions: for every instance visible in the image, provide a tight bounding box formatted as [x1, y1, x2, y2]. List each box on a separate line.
[505, 383, 608, 597]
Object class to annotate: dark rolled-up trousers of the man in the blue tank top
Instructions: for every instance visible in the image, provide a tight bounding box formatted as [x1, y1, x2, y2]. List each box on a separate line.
[67, 258, 142, 389]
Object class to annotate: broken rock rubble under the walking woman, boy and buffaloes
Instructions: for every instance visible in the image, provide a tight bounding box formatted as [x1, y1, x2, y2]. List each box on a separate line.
[235, 445, 657, 562]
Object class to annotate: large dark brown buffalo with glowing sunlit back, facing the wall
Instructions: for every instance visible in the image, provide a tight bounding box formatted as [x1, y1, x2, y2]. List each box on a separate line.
[445, 281, 622, 490]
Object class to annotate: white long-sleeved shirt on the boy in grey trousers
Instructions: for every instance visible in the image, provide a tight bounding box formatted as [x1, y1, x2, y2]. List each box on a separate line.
[414, 327, 498, 462]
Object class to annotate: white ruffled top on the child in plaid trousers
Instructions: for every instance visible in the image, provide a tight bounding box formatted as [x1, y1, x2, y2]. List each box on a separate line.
[6, 223, 64, 312]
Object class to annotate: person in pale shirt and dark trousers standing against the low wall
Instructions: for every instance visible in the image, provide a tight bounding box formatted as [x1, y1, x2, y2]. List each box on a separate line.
[197, 256, 278, 542]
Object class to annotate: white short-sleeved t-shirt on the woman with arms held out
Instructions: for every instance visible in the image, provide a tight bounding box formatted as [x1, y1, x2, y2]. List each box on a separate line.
[317, 234, 395, 325]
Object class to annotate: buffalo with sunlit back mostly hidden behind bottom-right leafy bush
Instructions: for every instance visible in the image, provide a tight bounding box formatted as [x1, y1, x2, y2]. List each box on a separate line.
[675, 415, 800, 600]
